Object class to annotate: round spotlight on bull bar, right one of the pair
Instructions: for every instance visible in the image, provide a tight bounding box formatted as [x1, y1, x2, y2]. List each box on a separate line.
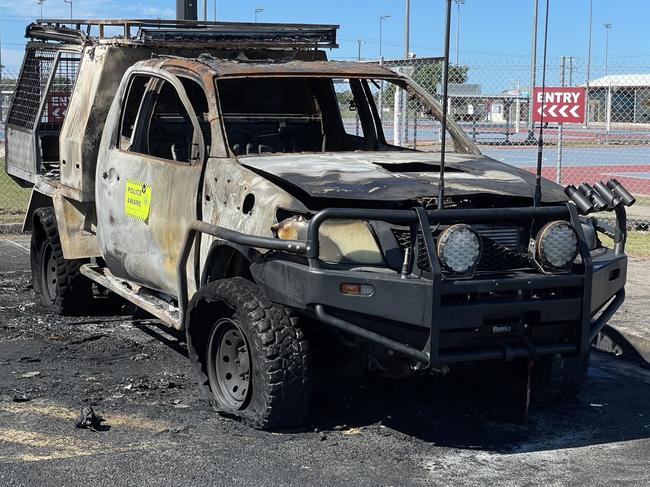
[536, 220, 578, 271]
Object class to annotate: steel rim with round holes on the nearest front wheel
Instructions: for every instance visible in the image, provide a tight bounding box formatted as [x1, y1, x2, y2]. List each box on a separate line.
[208, 318, 251, 409]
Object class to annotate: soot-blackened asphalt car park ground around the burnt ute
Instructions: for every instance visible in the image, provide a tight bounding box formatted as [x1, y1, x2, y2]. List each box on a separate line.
[0, 235, 650, 486]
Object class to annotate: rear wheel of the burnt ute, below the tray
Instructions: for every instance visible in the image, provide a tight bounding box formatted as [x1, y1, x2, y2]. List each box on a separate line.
[30, 208, 93, 315]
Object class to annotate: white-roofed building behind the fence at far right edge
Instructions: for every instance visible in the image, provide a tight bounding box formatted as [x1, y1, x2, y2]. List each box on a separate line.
[583, 73, 650, 124]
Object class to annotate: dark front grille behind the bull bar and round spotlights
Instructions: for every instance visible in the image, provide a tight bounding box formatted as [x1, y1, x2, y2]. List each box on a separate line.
[392, 225, 532, 273]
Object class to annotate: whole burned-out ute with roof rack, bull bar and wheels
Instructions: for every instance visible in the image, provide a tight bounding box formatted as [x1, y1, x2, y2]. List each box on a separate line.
[6, 20, 634, 428]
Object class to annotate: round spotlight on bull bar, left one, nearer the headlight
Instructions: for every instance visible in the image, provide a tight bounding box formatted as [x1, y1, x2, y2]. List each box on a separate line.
[438, 223, 481, 274]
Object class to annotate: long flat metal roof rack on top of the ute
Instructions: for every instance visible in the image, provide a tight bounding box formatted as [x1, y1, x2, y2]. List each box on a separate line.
[25, 19, 339, 49]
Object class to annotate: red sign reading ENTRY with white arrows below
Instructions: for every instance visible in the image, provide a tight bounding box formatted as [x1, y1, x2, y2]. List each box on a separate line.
[533, 86, 586, 123]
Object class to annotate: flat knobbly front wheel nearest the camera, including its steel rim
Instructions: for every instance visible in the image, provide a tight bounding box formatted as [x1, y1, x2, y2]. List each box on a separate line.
[185, 277, 311, 430]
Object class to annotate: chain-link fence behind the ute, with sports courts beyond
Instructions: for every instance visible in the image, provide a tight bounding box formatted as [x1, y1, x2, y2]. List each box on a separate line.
[0, 58, 650, 229]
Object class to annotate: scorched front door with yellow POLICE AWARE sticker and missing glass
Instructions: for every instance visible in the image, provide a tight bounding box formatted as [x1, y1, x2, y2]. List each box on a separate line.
[97, 72, 204, 295]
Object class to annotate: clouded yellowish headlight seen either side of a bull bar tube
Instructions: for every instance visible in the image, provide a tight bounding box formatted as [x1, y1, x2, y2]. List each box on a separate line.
[273, 216, 384, 265]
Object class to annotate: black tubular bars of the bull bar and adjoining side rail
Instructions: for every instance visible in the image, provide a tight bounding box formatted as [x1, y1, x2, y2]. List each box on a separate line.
[177, 203, 625, 367]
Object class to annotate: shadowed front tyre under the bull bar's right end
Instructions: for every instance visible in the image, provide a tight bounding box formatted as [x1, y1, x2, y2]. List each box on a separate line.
[532, 352, 589, 402]
